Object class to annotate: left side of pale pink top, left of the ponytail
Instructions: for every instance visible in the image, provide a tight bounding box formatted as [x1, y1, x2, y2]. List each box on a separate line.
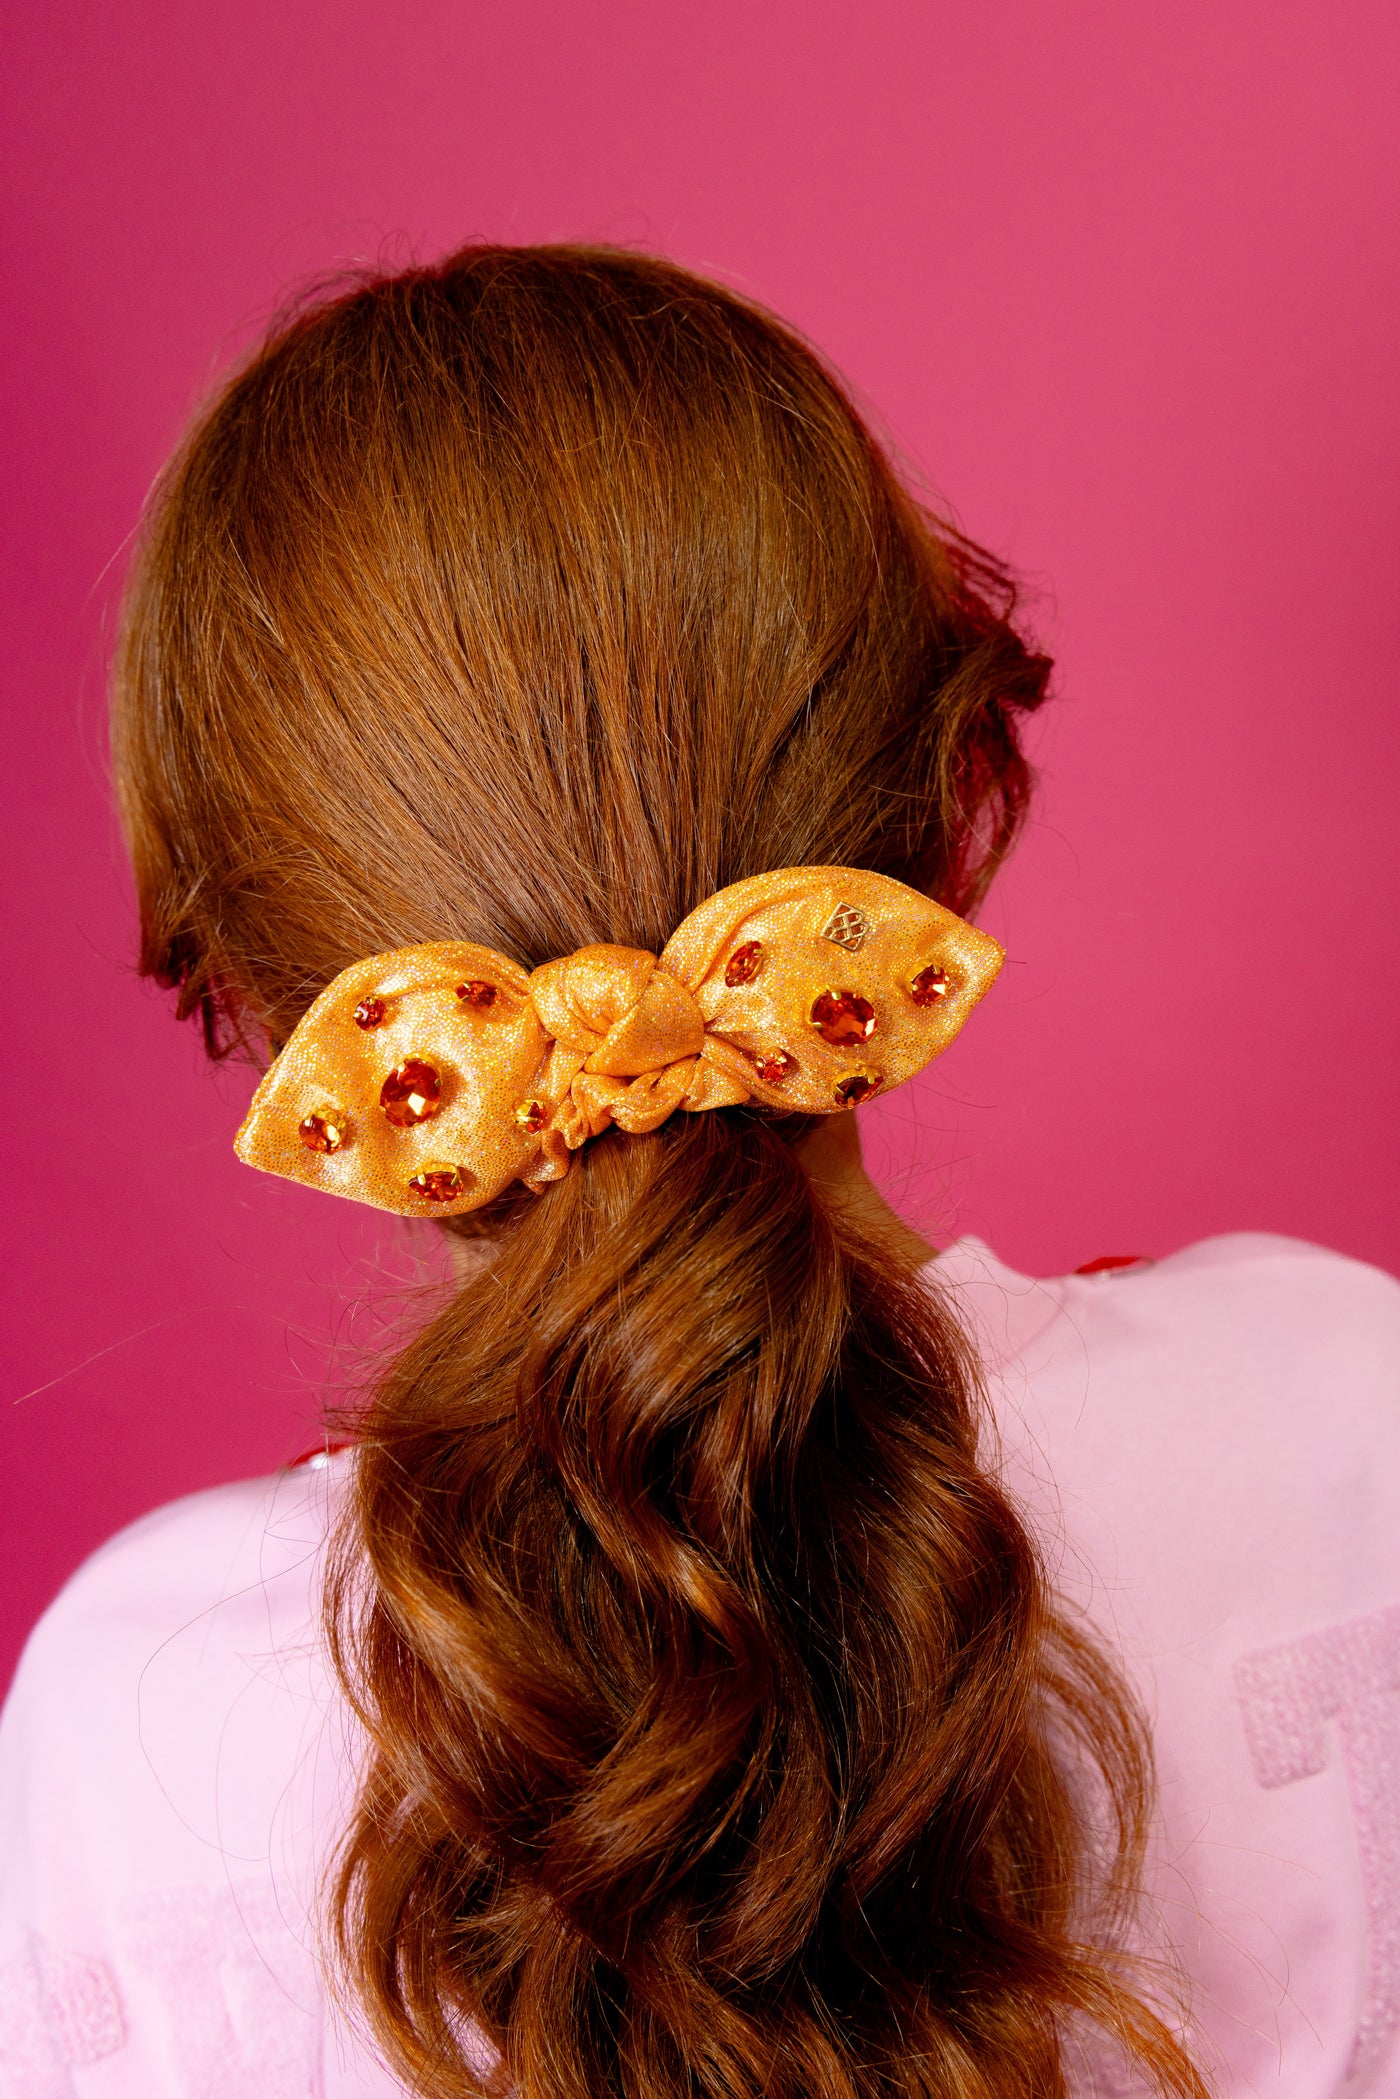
[0, 1461, 397, 2099]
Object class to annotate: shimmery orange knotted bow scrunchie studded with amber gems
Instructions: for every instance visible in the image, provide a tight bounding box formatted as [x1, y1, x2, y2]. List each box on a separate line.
[235, 867, 1003, 1217]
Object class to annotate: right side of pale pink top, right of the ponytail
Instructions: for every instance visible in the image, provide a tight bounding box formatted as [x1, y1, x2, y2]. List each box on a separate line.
[957, 1232, 1400, 2091]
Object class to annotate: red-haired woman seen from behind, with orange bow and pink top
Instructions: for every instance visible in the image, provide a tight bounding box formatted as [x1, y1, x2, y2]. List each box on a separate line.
[0, 248, 1400, 2099]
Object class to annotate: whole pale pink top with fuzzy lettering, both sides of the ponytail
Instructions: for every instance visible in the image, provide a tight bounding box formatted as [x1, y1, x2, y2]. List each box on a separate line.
[0, 1234, 1400, 2099]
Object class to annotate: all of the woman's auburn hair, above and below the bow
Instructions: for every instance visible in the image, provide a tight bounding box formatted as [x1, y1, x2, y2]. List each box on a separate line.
[115, 248, 1205, 2099]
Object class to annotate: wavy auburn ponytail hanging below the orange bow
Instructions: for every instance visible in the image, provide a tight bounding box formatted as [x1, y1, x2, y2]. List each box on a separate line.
[330, 1110, 1203, 2099]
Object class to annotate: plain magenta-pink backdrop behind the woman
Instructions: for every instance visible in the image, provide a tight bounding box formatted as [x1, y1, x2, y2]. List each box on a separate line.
[0, 0, 1400, 1671]
